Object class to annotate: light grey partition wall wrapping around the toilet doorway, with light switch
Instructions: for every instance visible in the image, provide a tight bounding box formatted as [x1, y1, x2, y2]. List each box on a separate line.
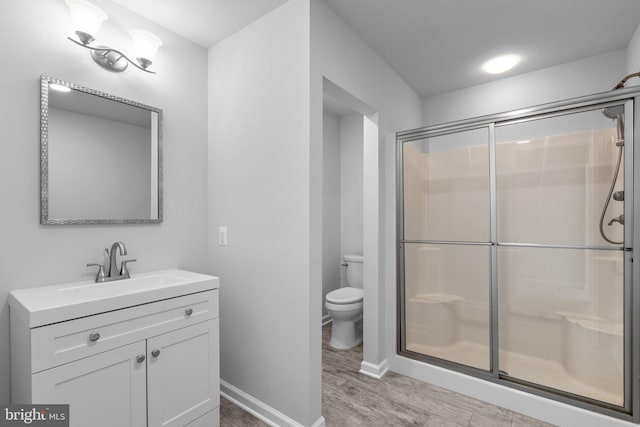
[209, 0, 421, 425]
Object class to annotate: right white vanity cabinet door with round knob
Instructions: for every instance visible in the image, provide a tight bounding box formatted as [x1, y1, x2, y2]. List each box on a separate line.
[147, 319, 220, 427]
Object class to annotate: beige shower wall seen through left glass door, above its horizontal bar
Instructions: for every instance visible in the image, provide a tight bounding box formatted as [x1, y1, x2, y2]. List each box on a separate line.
[404, 128, 489, 242]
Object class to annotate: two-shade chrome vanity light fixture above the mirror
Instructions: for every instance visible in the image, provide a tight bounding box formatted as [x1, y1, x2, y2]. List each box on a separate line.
[65, 0, 162, 74]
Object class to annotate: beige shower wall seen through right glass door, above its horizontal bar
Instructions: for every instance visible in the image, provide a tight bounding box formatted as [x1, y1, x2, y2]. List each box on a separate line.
[496, 122, 624, 246]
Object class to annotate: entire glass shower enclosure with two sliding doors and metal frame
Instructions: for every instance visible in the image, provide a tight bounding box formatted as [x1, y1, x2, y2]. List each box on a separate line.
[397, 89, 640, 420]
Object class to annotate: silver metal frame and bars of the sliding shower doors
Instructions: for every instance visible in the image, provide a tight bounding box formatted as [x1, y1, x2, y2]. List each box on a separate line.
[396, 87, 640, 422]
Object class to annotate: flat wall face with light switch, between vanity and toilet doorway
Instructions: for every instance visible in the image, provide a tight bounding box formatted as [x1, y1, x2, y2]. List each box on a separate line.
[209, 0, 322, 425]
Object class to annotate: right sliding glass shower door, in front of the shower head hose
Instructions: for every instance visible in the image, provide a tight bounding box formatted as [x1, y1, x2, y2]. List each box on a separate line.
[495, 106, 625, 406]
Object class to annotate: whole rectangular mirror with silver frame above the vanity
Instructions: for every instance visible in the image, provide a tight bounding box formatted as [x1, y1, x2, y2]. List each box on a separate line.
[40, 76, 162, 224]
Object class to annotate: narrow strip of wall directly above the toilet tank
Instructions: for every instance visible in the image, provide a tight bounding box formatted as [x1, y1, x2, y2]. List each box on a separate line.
[340, 113, 364, 257]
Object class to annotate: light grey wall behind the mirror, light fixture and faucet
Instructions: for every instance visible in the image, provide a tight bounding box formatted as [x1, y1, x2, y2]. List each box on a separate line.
[0, 0, 209, 402]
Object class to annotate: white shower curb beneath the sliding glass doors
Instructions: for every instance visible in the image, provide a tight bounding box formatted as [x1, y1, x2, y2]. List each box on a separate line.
[391, 355, 638, 427]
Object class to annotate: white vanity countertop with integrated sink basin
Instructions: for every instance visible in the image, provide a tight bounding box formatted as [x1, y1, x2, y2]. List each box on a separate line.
[8, 269, 220, 328]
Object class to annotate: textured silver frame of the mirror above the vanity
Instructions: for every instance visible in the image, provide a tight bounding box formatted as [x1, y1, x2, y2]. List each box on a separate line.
[40, 75, 163, 225]
